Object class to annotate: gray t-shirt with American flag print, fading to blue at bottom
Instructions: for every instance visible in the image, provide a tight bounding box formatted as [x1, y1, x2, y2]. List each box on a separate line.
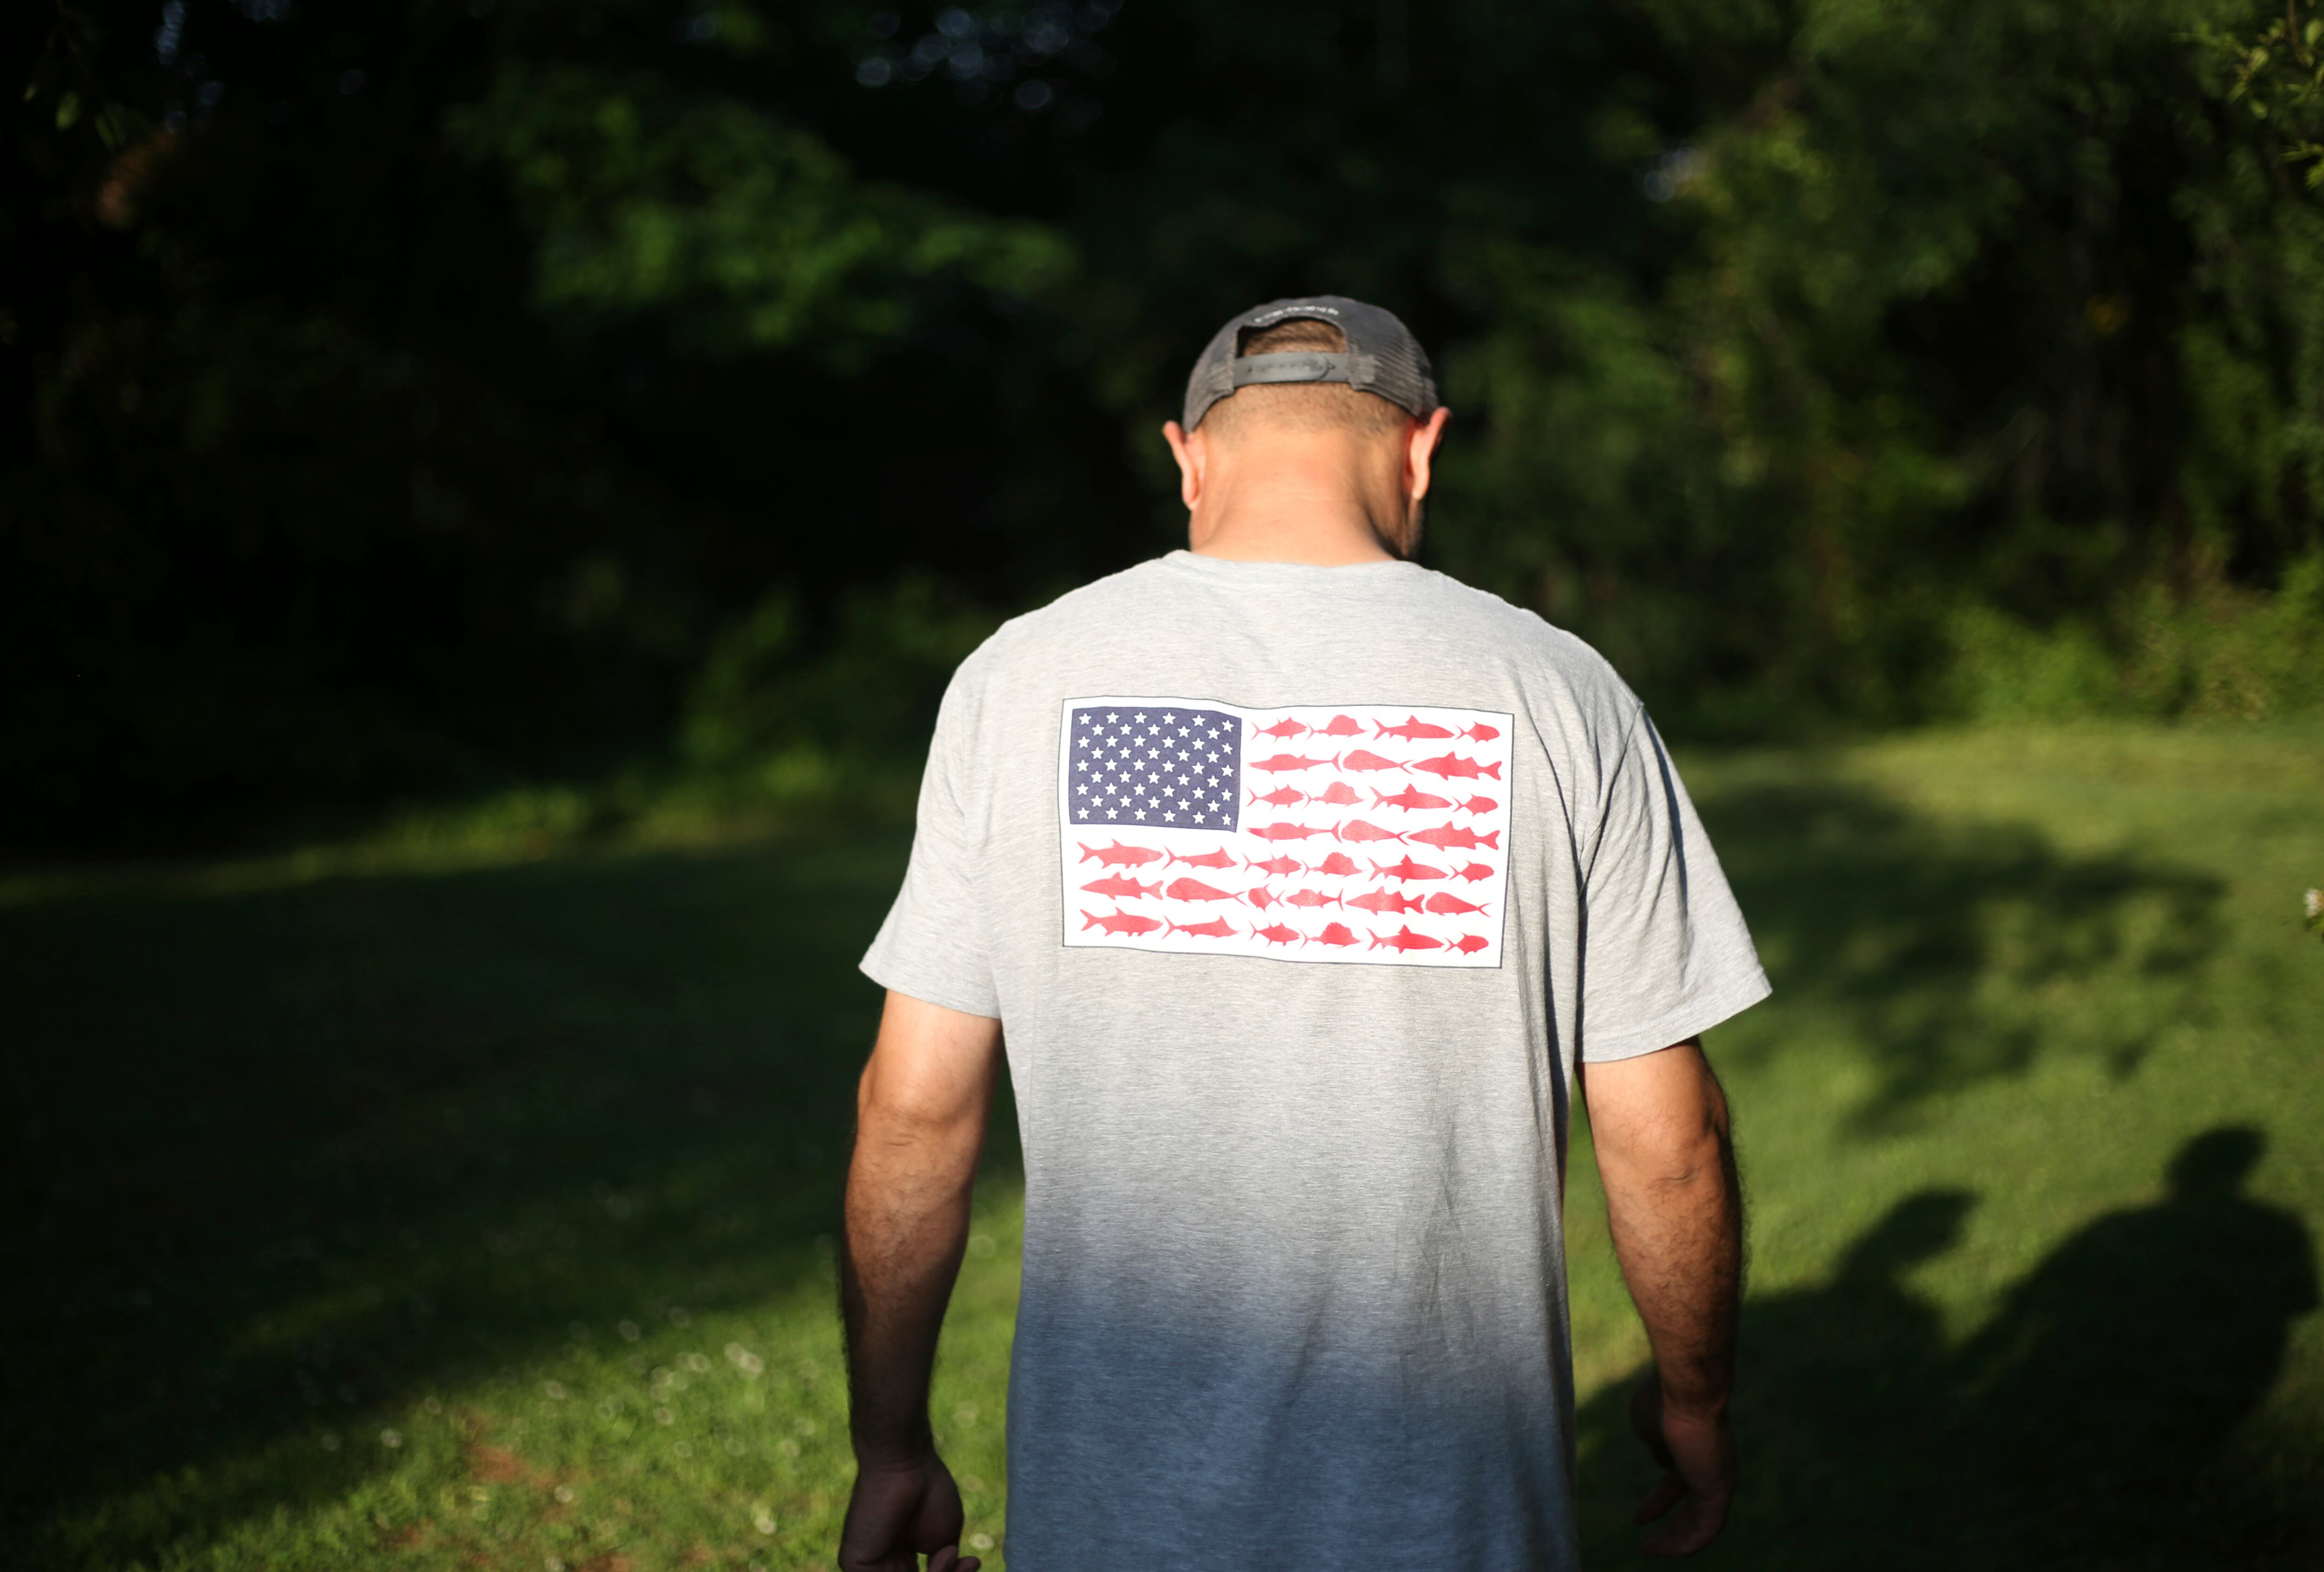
[865, 553, 1769, 1572]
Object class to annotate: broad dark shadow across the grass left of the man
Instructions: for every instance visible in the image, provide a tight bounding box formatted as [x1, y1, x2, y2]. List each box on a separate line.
[0, 836, 1016, 1567]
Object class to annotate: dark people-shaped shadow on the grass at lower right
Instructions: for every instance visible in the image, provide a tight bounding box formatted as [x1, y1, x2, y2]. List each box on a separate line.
[1580, 1129, 2324, 1572]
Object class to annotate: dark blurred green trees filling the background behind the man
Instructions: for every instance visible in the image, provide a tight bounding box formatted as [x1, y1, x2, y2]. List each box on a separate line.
[13, 0, 2324, 855]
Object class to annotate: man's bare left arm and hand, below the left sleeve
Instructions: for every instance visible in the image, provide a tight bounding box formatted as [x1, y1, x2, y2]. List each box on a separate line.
[839, 994, 1002, 1572]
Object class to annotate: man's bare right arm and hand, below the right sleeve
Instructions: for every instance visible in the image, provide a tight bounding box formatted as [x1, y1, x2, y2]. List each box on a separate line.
[1583, 1040, 1743, 1556]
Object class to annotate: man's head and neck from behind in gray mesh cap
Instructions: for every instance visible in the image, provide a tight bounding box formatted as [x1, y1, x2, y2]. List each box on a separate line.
[1164, 295, 1446, 559]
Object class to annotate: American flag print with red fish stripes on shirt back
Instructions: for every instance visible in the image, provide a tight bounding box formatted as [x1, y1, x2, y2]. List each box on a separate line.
[1057, 697, 1515, 968]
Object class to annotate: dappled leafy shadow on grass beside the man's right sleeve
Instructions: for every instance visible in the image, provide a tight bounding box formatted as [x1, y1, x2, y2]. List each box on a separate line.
[1701, 780, 2224, 1114]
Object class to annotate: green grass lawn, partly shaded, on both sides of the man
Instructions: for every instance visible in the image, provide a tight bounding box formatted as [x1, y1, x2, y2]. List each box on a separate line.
[0, 729, 2324, 1572]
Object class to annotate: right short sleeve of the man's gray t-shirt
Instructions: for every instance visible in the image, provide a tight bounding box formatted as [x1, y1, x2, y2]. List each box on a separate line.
[1580, 713, 1769, 1061]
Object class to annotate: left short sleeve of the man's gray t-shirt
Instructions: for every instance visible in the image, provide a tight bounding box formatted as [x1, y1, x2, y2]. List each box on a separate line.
[862, 657, 1002, 1017]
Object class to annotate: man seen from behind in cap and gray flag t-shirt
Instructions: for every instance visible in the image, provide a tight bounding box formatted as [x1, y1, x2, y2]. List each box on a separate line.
[839, 297, 1766, 1572]
